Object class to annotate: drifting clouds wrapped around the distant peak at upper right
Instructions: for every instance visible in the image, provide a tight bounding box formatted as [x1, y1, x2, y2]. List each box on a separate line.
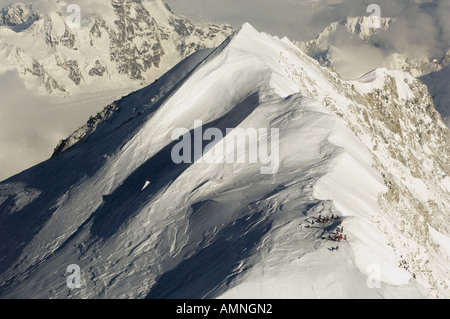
[304, 0, 450, 79]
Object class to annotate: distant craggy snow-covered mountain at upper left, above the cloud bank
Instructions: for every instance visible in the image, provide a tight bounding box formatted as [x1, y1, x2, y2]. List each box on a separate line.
[0, 0, 232, 95]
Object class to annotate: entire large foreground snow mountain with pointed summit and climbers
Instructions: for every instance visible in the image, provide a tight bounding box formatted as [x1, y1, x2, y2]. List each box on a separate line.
[0, 24, 450, 298]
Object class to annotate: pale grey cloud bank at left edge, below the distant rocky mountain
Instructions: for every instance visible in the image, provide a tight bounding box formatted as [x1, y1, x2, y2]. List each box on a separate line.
[0, 70, 117, 181]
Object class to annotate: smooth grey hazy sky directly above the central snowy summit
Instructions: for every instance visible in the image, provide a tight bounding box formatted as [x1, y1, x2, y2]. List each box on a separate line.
[166, 0, 422, 41]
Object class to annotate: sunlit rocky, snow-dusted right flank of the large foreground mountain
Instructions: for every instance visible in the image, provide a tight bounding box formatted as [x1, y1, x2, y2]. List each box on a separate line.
[274, 46, 450, 296]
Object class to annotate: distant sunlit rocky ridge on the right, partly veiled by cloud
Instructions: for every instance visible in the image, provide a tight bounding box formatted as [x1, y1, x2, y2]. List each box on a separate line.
[295, 17, 450, 131]
